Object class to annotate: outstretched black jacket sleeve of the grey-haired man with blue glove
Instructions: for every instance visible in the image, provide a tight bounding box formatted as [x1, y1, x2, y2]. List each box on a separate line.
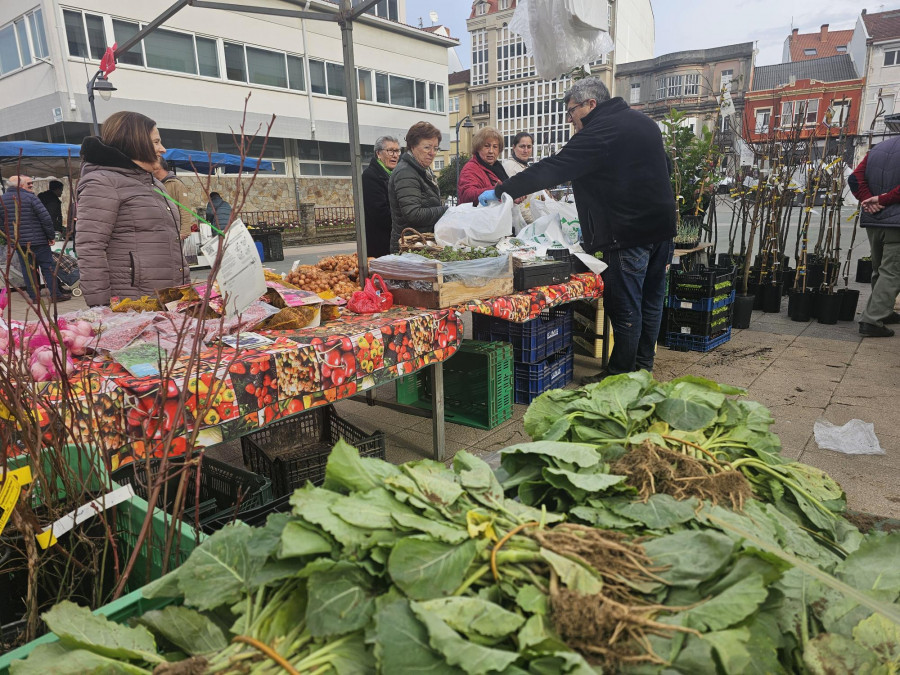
[494, 131, 603, 199]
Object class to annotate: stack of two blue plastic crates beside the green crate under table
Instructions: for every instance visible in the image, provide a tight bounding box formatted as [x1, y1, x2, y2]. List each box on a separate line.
[472, 306, 575, 404]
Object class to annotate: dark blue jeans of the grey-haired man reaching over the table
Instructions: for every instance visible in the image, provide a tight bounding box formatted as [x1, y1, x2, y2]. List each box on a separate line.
[603, 239, 675, 375]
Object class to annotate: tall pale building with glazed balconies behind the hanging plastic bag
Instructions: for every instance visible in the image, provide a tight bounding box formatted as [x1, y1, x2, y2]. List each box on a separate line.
[462, 0, 654, 159]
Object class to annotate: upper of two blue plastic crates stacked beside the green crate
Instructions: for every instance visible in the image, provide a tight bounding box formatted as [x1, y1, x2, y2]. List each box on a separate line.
[472, 305, 572, 363]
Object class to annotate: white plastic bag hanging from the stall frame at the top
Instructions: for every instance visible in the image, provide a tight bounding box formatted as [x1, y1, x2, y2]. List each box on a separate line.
[509, 0, 614, 80]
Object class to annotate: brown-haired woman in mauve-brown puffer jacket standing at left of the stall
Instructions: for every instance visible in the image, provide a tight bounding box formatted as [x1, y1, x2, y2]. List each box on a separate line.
[75, 112, 189, 307]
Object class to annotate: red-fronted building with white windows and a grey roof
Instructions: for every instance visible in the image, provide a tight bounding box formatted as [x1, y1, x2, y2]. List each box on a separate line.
[744, 54, 864, 161]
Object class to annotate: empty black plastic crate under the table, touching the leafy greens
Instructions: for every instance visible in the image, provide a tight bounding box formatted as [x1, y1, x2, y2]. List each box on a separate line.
[241, 406, 385, 497]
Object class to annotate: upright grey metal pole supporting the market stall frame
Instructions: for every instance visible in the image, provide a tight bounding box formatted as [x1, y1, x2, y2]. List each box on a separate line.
[338, 0, 369, 288]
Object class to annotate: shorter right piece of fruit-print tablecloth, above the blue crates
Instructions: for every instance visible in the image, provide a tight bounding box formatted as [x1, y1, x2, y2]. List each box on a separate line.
[459, 273, 603, 323]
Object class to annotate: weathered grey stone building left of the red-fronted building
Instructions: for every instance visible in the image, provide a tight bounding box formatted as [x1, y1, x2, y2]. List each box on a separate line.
[615, 42, 755, 169]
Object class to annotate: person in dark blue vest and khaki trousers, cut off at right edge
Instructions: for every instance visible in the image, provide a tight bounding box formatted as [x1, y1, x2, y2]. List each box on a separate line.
[848, 137, 900, 337]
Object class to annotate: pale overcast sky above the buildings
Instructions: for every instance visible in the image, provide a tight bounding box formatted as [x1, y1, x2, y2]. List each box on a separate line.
[406, 0, 860, 67]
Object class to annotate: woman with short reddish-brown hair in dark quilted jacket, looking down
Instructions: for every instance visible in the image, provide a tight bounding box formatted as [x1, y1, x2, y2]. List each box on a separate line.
[388, 122, 447, 253]
